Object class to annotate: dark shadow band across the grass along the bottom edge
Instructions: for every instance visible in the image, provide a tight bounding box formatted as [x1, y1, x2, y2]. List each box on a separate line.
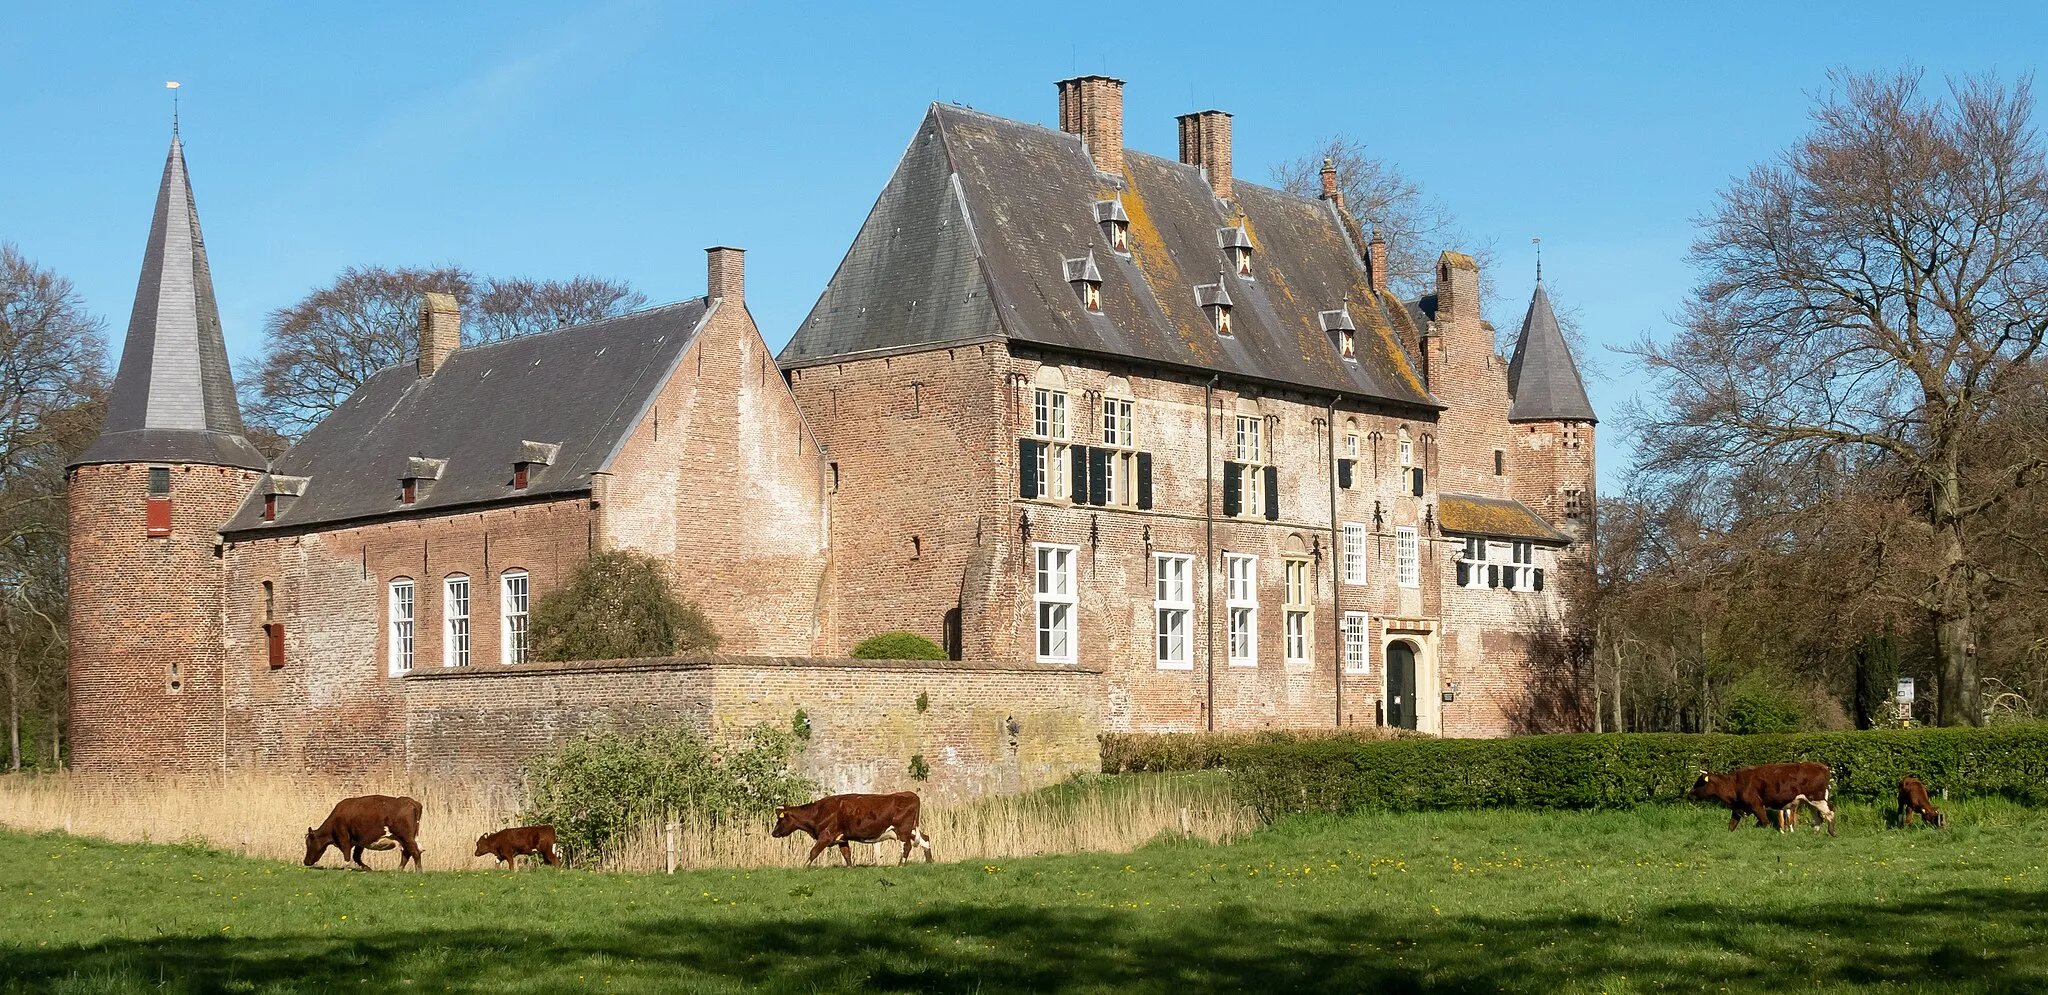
[0, 889, 2048, 993]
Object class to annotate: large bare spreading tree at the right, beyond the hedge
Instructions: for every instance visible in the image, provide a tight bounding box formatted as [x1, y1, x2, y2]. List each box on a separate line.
[1634, 74, 2048, 725]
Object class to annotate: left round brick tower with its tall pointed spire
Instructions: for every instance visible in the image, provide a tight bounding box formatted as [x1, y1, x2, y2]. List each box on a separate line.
[70, 129, 266, 776]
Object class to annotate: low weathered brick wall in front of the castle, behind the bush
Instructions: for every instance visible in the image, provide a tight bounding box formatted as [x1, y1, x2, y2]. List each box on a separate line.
[403, 657, 1102, 798]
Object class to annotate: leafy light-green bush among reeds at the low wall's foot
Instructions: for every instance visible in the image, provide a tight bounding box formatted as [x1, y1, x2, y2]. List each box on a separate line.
[520, 725, 813, 864]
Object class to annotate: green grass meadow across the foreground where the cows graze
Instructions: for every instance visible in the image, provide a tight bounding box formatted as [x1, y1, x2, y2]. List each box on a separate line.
[0, 803, 2048, 993]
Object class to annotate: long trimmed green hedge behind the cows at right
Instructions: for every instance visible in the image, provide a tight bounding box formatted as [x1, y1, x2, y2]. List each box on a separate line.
[1212, 725, 2048, 817]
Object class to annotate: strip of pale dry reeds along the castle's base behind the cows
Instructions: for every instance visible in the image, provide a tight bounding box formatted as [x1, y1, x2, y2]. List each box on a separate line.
[0, 774, 1255, 872]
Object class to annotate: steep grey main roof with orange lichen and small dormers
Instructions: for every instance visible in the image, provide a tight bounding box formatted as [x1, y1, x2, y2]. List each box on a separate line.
[778, 104, 1440, 407]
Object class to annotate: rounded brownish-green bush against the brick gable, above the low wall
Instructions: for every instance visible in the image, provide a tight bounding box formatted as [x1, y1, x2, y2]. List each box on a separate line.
[532, 551, 719, 661]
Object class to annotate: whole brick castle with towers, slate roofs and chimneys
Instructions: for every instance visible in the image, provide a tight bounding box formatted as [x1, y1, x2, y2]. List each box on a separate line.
[70, 76, 1595, 790]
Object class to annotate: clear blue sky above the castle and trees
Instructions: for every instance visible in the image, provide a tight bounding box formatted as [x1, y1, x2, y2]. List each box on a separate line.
[0, 0, 2048, 485]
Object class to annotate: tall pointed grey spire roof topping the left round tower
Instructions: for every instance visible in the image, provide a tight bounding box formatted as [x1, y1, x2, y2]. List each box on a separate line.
[78, 129, 266, 469]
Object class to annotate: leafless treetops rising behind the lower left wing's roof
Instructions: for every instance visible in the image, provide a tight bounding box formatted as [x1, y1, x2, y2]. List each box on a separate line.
[240, 266, 647, 438]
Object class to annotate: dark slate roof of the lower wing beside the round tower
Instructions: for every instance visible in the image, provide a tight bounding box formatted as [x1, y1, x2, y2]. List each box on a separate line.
[221, 299, 711, 538]
